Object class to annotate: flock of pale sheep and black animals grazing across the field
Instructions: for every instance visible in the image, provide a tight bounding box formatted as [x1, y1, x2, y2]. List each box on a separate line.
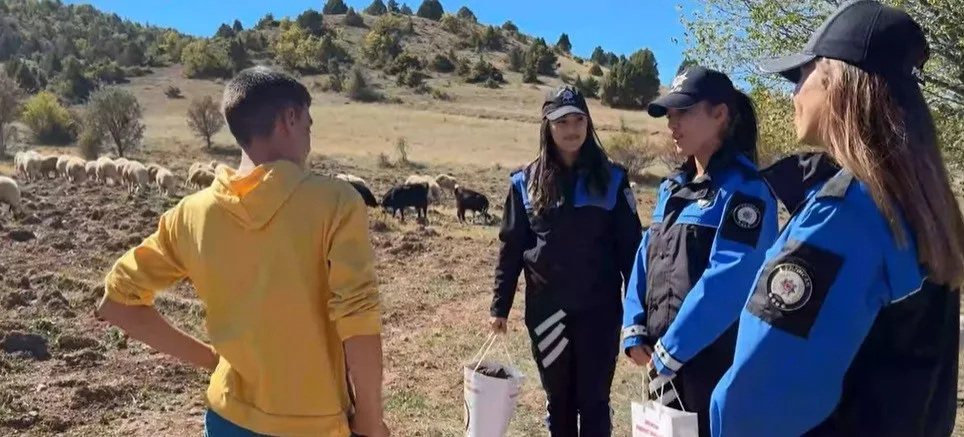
[0, 150, 489, 225]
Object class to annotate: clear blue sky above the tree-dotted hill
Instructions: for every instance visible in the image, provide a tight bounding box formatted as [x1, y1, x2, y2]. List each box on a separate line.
[65, 0, 691, 83]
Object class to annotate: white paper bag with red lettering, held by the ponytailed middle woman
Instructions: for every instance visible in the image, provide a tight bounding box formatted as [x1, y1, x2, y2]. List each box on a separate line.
[632, 373, 700, 437]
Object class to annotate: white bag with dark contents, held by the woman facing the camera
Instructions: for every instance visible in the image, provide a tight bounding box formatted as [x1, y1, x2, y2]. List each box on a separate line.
[462, 334, 525, 437]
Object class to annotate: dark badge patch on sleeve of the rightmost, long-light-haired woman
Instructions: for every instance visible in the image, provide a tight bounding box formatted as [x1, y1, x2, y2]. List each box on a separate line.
[746, 240, 844, 338]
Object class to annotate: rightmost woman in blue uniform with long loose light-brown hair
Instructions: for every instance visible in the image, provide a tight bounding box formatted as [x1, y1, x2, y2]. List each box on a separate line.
[711, 0, 964, 437]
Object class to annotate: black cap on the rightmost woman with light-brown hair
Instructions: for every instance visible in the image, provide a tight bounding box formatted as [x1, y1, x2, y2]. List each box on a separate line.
[757, 0, 930, 83]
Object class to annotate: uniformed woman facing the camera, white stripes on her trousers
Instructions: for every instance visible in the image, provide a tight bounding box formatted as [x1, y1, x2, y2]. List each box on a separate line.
[491, 87, 642, 437]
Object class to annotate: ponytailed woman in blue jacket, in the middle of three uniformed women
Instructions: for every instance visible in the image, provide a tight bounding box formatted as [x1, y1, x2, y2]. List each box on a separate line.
[623, 66, 778, 436]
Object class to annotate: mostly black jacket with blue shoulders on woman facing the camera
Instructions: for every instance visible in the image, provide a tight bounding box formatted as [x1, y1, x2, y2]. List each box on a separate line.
[490, 160, 642, 320]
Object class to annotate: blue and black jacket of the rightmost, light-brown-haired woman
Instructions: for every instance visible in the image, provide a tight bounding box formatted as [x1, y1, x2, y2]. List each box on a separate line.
[711, 154, 960, 437]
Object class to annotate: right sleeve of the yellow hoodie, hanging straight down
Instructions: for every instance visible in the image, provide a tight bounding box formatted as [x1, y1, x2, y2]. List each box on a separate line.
[327, 184, 381, 341]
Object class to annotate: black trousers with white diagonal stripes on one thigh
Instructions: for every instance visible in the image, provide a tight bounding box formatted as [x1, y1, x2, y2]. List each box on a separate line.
[525, 302, 622, 437]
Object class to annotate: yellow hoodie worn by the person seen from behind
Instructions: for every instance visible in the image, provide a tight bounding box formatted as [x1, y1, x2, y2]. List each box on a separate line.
[105, 161, 381, 437]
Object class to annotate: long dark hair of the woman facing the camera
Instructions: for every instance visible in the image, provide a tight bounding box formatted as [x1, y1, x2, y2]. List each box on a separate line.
[526, 117, 609, 214]
